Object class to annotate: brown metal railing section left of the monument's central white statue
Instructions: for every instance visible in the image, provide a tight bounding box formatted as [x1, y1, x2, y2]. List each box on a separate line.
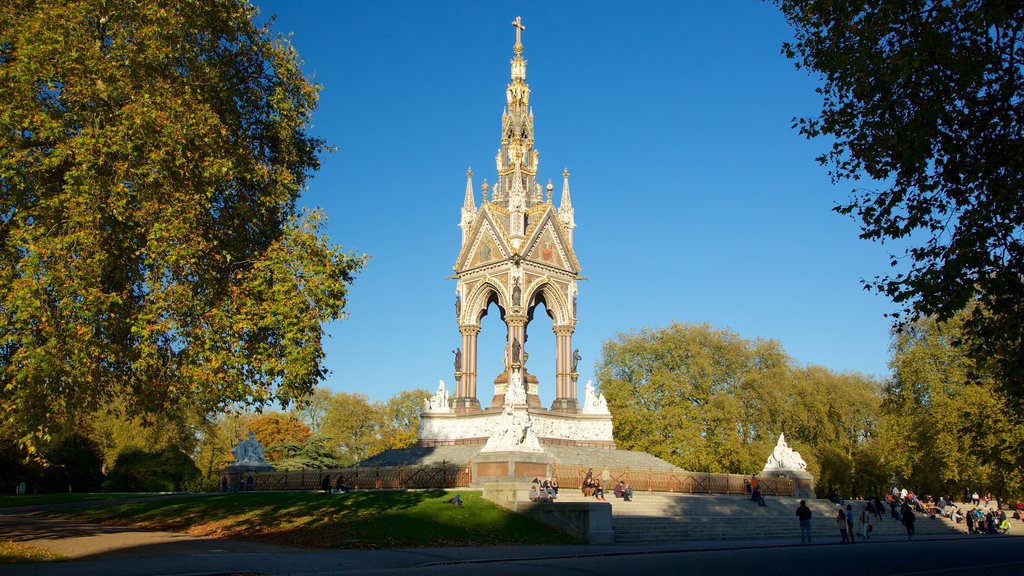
[252, 462, 472, 490]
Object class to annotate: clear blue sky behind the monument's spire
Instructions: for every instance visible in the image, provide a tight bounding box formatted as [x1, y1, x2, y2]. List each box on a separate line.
[256, 0, 894, 406]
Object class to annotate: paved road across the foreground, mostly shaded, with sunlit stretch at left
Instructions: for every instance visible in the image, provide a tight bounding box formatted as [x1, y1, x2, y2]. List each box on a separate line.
[0, 500, 1024, 576]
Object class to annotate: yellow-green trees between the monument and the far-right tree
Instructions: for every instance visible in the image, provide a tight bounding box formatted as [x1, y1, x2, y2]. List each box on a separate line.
[597, 323, 879, 494]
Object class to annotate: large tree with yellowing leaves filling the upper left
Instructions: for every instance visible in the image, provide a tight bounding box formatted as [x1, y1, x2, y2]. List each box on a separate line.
[0, 0, 365, 450]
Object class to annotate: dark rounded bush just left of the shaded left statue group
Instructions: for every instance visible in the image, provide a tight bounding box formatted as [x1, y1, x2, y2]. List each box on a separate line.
[103, 446, 200, 492]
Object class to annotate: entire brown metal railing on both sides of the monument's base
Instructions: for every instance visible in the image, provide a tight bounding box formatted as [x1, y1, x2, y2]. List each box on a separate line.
[241, 462, 793, 496]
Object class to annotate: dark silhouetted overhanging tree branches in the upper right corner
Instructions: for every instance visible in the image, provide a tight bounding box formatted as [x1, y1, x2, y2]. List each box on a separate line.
[775, 0, 1024, 399]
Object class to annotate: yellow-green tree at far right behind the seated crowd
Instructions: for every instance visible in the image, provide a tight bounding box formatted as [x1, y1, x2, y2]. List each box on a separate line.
[882, 312, 1024, 497]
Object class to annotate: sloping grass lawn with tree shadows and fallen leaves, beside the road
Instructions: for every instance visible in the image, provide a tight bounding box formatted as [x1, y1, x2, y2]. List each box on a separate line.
[44, 490, 581, 548]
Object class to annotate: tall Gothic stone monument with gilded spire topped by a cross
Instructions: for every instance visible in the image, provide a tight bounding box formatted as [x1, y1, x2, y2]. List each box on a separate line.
[418, 17, 614, 477]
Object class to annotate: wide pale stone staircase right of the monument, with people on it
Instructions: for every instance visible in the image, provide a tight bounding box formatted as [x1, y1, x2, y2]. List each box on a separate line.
[558, 490, 965, 544]
